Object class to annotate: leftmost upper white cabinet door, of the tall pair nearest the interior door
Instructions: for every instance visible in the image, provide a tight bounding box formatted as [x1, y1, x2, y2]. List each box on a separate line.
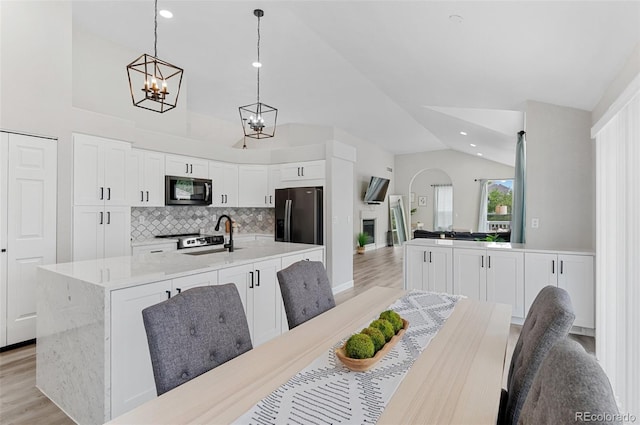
[73, 134, 105, 205]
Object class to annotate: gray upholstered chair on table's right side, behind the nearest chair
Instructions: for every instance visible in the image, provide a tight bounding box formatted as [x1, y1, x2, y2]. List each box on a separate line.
[498, 286, 575, 425]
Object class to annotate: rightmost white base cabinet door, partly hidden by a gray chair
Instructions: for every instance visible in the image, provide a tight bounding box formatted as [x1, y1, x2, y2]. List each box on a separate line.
[558, 254, 596, 329]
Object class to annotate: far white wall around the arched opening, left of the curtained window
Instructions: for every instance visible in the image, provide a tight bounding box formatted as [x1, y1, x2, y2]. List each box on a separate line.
[394, 149, 515, 231]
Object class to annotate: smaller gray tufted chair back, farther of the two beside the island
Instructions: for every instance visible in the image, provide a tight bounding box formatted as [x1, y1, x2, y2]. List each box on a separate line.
[278, 261, 336, 329]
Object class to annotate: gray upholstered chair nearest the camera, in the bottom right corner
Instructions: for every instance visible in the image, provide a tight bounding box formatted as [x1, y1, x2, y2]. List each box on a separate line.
[518, 339, 622, 425]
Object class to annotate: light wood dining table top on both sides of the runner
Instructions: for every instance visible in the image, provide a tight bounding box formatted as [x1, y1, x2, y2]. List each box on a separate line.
[109, 287, 511, 425]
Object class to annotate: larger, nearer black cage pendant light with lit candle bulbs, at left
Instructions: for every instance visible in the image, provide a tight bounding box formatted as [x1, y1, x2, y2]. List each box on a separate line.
[127, 0, 183, 113]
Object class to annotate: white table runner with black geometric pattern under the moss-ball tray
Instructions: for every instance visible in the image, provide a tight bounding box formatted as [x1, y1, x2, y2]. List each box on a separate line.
[235, 291, 462, 425]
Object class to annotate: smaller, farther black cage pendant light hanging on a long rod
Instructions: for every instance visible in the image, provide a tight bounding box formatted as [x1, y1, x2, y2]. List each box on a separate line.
[238, 9, 278, 139]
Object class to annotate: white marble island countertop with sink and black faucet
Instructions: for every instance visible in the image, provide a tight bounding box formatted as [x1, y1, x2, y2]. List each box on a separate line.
[40, 240, 321, 290]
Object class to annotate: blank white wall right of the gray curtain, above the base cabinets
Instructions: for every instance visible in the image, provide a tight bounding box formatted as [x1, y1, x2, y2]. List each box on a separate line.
[525, 101, 596, 250]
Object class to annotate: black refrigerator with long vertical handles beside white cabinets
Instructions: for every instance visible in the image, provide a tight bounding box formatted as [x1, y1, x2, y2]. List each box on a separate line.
[275, 187, 323, 245]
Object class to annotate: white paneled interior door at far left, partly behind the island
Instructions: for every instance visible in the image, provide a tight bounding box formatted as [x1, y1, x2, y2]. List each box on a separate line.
[7, 134, 57, 344]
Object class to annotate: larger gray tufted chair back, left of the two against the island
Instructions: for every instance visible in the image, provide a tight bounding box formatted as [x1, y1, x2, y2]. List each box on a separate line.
[142, 283, 253, 395]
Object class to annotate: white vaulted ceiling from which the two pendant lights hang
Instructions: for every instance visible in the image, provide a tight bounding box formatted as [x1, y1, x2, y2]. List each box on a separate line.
[73, 0, 640, 164]
